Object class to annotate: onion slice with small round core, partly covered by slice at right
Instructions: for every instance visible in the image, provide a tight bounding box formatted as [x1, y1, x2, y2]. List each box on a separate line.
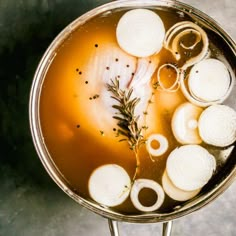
[171, 102, 203, 144]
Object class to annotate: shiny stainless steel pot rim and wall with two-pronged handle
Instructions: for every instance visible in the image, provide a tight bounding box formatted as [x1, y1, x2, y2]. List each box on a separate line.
[29, 0, 236, 235]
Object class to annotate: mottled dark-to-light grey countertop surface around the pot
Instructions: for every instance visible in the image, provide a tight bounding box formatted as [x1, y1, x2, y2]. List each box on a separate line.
[0, 0, 236, 236]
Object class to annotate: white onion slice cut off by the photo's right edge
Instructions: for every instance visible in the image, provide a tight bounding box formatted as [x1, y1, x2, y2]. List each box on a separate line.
[199, 105, 236, 147]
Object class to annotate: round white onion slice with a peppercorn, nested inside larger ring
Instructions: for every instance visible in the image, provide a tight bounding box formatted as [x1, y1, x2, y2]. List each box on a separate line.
[188, 58, 231, 102]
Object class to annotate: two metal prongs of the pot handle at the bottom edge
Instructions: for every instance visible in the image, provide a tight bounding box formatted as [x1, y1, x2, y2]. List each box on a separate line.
[108, 219, 172, 236]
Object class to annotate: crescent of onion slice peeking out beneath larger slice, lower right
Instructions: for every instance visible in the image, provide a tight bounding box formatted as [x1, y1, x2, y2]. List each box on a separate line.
[162, 171, 201, 201]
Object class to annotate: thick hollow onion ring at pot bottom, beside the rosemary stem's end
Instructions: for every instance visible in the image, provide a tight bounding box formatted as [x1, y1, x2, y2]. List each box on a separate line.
[130, 179, 165, 212]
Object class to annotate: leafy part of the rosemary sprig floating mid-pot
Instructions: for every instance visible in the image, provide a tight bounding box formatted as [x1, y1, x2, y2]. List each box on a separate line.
[107, 78, 144, 151]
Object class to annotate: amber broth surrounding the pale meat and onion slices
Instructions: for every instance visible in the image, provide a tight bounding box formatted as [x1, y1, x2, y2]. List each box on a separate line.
[40, 7, 233, 214]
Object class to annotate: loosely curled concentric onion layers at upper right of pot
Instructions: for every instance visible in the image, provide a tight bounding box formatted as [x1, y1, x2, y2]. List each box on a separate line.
[164, 21, 209, 70]
